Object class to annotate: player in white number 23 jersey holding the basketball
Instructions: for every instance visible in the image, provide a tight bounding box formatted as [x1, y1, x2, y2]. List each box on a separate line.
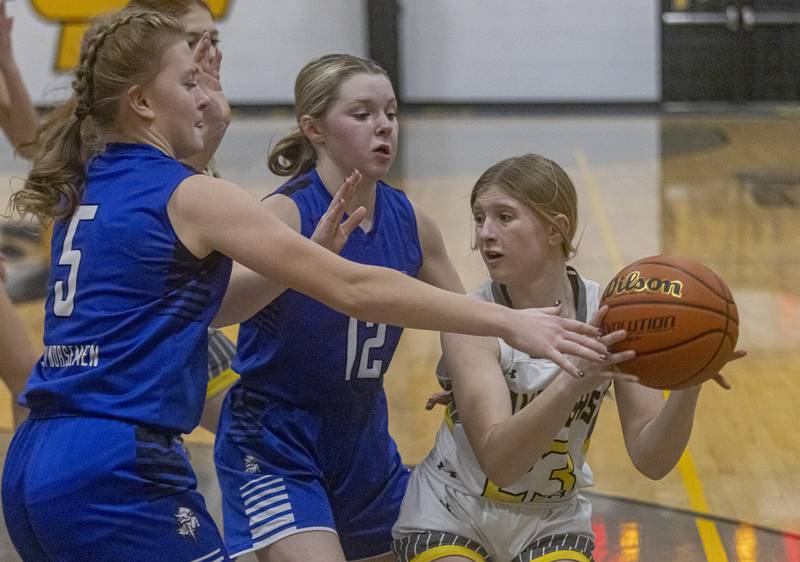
[393, 154, 743, 562]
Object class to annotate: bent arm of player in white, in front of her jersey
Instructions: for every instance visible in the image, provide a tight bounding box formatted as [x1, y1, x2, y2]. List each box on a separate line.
[442, 308, 633, 487]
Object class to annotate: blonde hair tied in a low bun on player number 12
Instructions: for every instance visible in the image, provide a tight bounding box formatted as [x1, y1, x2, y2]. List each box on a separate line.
[267, 54, 389, 177]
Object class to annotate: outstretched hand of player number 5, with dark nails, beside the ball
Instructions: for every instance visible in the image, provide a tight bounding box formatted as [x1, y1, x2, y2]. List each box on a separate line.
[505, 305, 609, 378]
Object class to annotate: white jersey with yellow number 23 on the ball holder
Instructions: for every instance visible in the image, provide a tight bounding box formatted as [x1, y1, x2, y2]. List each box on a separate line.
[423, 268, 609, 504]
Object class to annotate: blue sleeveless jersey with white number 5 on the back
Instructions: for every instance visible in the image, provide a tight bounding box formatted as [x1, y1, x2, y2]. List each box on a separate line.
[21, 144, 231, 433]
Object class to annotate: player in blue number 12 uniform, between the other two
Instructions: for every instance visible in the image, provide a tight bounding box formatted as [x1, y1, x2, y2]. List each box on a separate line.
[215, 55, 564, 562]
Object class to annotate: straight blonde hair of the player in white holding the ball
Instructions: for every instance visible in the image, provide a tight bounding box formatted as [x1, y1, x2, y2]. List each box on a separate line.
[469, 154, 578, 259]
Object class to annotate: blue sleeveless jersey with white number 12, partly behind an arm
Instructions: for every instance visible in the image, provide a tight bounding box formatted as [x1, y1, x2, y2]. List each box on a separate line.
[234, 170, 422, 405]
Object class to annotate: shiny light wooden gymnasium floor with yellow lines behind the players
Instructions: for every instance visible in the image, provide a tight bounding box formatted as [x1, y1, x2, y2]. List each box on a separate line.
[0, 110, 800, 562]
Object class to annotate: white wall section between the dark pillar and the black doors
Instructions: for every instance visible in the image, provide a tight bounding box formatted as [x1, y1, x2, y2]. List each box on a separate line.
[400, 0, 660, 102]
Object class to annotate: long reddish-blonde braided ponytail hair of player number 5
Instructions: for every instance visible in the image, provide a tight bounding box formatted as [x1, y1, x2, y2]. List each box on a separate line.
[10, 9, 185, 220]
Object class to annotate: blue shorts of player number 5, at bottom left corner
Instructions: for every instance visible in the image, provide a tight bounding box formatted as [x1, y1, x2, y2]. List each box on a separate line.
[2, 416, 230, 562]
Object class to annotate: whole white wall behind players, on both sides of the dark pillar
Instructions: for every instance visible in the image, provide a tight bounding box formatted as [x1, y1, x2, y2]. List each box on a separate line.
[8, 0, 660, 104]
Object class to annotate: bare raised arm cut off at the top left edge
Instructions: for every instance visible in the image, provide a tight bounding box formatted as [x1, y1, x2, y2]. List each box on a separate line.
[0, 0, 39, 158]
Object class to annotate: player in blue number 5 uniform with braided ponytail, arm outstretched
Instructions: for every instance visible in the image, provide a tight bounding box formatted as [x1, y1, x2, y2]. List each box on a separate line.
[2, 10, 604, 561]
